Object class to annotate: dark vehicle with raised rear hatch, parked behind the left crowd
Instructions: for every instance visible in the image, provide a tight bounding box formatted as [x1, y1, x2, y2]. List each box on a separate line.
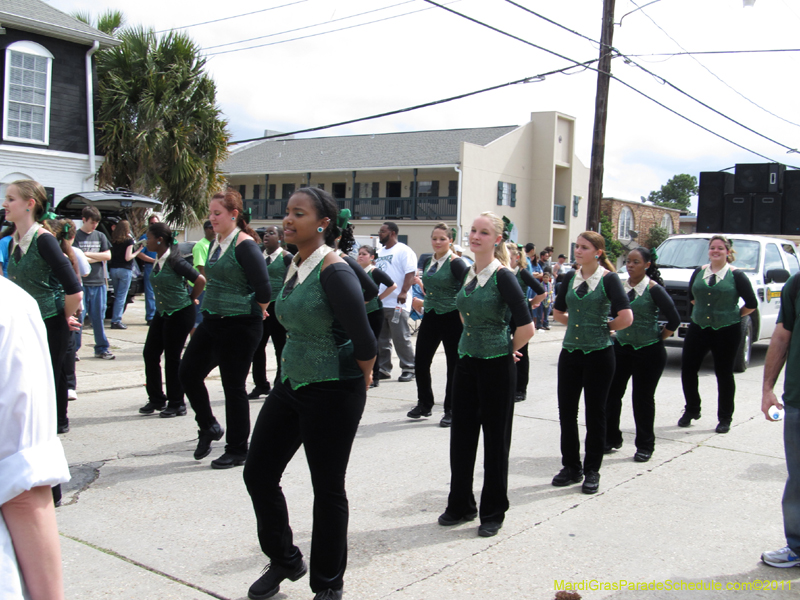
[55, 189, 161, 319]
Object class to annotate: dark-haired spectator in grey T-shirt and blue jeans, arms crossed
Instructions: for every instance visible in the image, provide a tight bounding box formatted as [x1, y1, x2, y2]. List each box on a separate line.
[73, 206, 116, 360]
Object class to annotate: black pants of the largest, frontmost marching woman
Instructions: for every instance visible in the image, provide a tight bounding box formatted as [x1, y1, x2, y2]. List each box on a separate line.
[244, 377, 367, 593]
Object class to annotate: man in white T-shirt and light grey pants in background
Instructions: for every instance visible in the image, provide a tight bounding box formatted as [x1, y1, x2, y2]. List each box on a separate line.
[375, 221, 417, 382]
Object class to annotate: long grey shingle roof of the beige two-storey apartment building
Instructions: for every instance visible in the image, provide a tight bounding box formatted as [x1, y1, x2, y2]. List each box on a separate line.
[222, 126, 517, 175]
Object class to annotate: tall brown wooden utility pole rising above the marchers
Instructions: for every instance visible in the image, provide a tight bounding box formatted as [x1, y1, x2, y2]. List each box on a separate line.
[586, 0, 614, 232]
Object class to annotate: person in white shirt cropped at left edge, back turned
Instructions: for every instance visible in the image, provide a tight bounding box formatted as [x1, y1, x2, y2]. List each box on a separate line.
[0, 278, 69, 600]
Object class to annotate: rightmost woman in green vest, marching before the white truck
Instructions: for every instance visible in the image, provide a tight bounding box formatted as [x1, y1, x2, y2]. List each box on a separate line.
[678, 235, 758, 433]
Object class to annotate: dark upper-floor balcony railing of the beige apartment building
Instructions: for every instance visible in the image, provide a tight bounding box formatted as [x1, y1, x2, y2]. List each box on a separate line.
[244, 196, 458, 221]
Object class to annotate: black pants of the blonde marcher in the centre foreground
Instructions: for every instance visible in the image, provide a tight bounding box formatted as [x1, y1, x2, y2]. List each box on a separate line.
[446, 356, 516, 523]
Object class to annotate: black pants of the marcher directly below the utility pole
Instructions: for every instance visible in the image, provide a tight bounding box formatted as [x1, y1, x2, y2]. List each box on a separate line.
[558, 346, 615, 471]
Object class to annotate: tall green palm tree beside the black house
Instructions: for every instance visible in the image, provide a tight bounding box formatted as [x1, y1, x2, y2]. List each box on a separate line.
[97, 27, 229, 226]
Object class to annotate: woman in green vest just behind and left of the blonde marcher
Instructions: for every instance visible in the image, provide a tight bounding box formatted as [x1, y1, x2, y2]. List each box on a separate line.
[407, 223, 469, 427]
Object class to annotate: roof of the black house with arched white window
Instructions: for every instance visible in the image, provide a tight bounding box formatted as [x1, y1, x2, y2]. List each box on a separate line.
[0, 0, 121, 48]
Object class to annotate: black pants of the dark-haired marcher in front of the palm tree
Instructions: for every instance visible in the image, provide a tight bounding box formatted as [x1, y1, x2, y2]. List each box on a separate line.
[142, 304, 195, 406]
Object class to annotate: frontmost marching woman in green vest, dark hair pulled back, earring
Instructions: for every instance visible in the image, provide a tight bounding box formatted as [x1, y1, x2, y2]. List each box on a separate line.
[244, 188, 377, 600]
